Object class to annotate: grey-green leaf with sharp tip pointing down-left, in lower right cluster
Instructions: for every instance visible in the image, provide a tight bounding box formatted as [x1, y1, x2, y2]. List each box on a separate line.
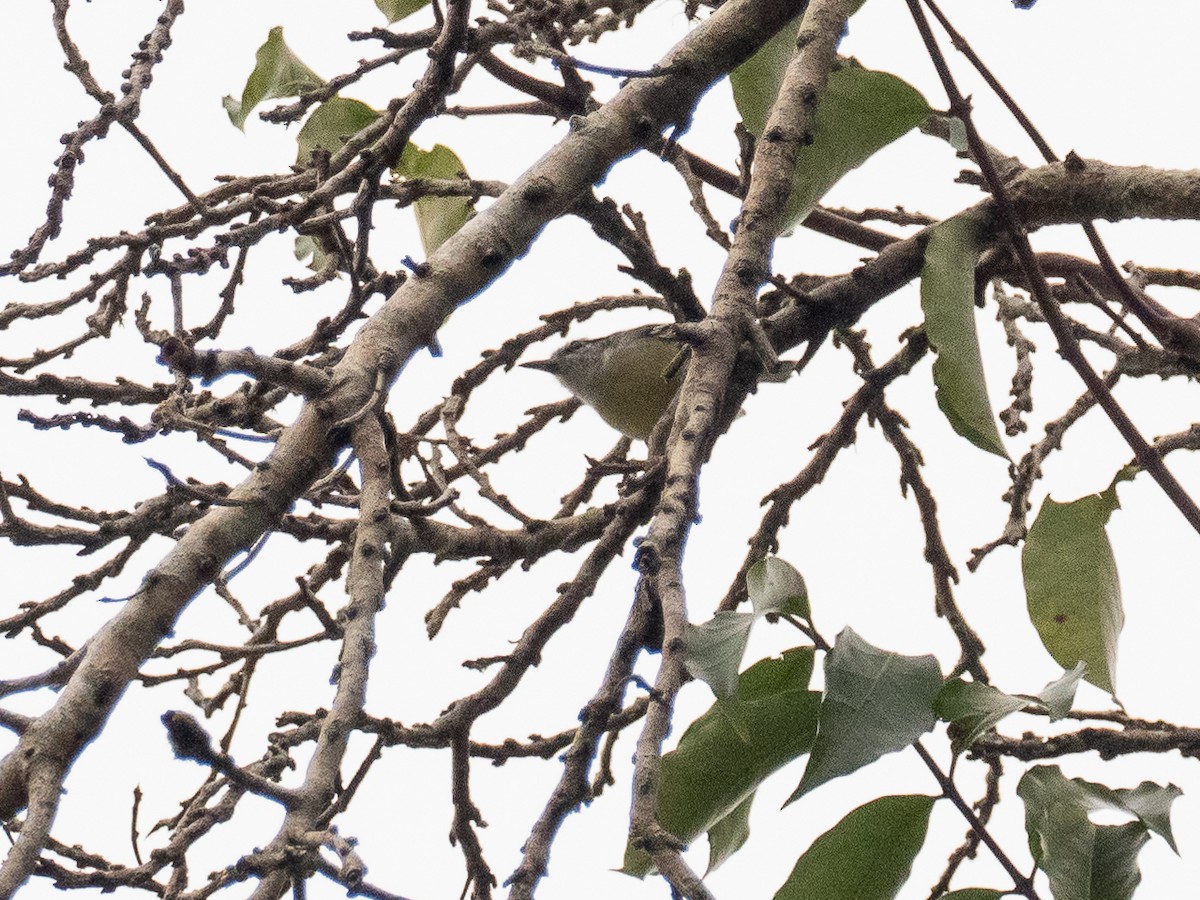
[787, 628, 942, 803]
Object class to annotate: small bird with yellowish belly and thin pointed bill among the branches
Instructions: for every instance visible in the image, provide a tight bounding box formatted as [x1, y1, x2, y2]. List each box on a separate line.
[521, 325, 686, 440]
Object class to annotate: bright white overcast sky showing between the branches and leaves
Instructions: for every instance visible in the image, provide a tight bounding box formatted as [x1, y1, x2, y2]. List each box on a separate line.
[0, 0, 1200, 900]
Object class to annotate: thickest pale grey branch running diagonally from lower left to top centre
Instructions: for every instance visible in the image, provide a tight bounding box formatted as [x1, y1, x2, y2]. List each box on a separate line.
[0, 0, 803, 884]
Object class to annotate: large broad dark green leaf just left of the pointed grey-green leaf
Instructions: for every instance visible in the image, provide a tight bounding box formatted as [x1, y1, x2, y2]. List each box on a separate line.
[622, 647, 821, 877]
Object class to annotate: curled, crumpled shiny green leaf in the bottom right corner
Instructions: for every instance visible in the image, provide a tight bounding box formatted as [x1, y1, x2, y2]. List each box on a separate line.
[1016, 766, 1181, 900]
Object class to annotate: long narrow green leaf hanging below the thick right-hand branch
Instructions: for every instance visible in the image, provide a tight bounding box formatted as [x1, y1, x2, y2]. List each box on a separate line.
[920, 215, 1008, 458]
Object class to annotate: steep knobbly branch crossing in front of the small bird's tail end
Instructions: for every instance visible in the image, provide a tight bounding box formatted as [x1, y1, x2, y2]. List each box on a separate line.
[630, 0, 851, 898]
